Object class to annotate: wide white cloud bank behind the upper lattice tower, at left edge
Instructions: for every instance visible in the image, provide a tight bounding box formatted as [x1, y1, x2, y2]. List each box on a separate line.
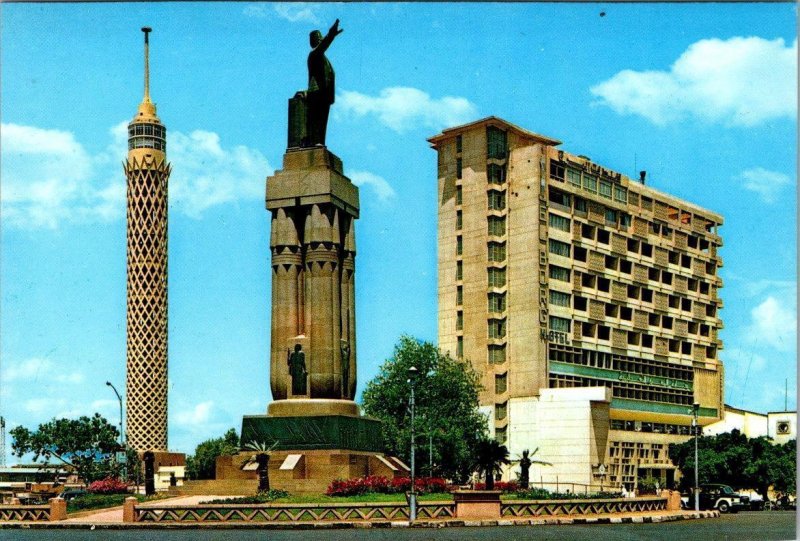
[0, 122, 272, 229]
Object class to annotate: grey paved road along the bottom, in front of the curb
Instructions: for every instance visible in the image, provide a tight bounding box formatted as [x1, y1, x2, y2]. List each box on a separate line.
[0, 511, 797, 541]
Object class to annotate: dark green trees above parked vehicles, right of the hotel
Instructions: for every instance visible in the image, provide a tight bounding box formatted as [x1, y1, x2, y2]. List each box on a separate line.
[669, 429, 797, 497]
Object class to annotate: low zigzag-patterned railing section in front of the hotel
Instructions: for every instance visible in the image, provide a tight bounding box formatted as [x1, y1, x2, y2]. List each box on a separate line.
[500, 497, 667, 518]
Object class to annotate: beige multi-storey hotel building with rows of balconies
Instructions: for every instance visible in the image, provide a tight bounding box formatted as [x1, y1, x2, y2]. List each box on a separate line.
[429, 117, 723, 487]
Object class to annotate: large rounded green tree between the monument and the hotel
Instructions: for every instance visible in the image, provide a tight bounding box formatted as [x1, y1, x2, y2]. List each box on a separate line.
[363, 336, 486, 480]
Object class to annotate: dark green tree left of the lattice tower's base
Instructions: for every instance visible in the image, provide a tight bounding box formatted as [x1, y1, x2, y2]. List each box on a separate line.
[9, 413, 119, 483]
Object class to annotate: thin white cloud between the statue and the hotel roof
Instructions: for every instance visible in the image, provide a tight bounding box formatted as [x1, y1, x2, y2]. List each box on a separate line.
[335, 86, 478, 133]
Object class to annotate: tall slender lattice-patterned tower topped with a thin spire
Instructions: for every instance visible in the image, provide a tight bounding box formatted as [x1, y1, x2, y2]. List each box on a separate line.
[123, 27, 171, 452]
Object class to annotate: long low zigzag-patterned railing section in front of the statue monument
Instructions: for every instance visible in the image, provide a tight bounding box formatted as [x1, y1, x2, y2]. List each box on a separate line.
[132, 502, 455, 523]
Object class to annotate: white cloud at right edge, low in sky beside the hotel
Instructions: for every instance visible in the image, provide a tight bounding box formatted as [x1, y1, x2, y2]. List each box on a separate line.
[745, 290, 797, 351]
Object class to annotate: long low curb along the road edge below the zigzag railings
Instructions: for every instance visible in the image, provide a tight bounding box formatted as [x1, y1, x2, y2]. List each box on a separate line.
[0, 511, 720, 530]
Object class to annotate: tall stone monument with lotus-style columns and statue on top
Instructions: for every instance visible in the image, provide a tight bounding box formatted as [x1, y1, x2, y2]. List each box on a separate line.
[225, 19, 407, 493]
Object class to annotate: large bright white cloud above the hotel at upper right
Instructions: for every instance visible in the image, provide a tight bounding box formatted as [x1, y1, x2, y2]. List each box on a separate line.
[590, 37, 797, 126]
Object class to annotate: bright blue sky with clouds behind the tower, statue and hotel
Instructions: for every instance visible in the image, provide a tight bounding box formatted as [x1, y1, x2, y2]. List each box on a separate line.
[0, 3, 797, 462]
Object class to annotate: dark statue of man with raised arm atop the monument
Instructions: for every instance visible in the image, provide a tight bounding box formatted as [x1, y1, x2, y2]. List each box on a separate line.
[306, 19, 344, 146]
